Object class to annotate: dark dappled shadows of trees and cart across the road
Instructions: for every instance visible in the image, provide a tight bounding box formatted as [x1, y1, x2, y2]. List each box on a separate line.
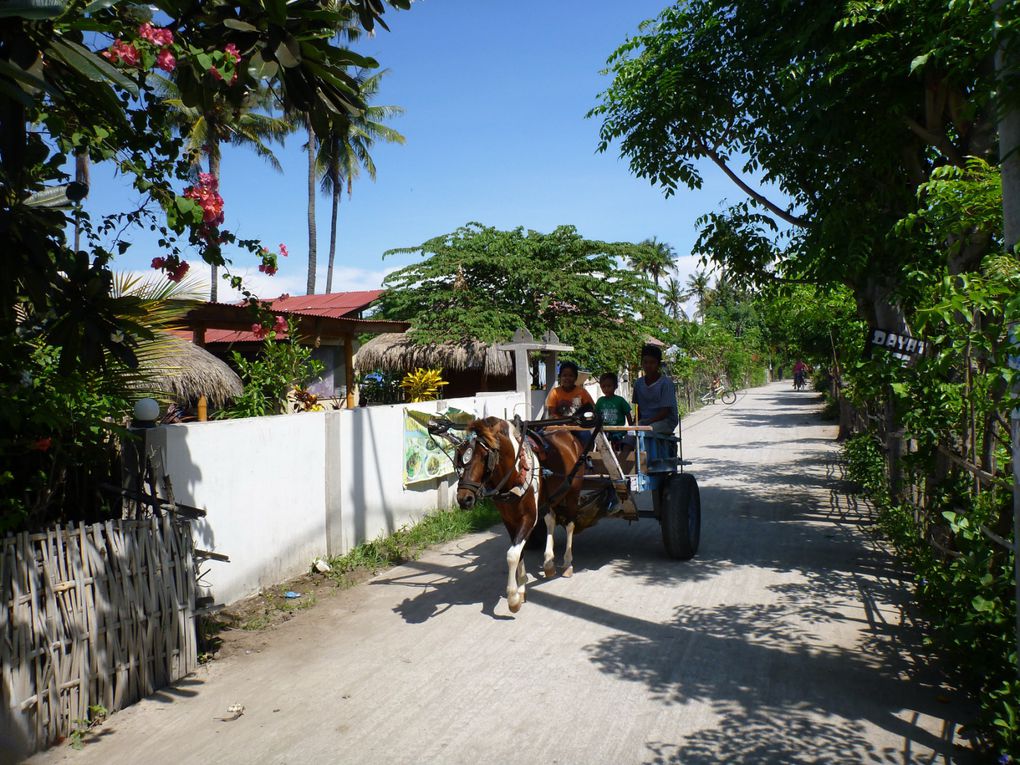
[380, 393, 971, 765]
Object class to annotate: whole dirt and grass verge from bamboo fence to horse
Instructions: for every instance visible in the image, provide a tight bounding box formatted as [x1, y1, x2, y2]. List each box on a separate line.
[199, 502, 500, 652]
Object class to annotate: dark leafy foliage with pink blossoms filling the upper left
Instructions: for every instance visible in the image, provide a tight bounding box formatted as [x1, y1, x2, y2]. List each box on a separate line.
[0, 0, 410, 527]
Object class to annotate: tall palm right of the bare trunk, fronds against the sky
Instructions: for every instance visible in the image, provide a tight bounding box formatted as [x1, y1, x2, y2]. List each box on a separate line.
[318, 69, 405, 293]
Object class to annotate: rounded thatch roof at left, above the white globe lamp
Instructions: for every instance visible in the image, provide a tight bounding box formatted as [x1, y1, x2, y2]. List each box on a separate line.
[139, 336, 244, 407]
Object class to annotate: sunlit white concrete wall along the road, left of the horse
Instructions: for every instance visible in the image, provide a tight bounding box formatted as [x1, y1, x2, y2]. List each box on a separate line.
[148, 392, 527, 603]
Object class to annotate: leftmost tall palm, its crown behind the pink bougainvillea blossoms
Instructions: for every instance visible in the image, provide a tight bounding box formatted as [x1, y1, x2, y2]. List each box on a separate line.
[161, 78, 292, 302]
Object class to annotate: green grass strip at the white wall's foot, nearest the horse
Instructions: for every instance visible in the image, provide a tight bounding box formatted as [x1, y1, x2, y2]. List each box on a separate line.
[326, 502, 500, 588]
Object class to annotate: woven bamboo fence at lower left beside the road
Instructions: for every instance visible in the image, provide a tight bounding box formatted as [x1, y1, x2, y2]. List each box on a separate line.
[0, 515, 198, 751]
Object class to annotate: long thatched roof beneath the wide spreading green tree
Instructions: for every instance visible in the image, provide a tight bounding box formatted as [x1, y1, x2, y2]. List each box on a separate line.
[354, 333, 513, 376]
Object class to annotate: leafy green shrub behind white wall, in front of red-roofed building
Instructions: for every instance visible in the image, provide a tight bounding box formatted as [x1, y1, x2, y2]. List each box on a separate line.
[220, 317, 323, 418]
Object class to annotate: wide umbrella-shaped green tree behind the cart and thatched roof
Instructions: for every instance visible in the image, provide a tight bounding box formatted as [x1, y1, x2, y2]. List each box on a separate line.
[381, 223, 671, 370]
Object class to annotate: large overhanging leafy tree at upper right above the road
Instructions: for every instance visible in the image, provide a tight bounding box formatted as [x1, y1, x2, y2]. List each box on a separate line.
[591, 0, 1016, 329]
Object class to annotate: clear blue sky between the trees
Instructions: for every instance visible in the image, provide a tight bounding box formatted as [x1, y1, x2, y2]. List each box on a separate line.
[88, 0, 740, 300]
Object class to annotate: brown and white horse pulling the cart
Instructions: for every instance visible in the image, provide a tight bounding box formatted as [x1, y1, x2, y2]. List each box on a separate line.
[455, 417, 584, 613]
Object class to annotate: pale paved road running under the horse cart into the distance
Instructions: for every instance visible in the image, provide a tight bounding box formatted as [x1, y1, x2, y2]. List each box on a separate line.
[31, 384, 960, 765]
